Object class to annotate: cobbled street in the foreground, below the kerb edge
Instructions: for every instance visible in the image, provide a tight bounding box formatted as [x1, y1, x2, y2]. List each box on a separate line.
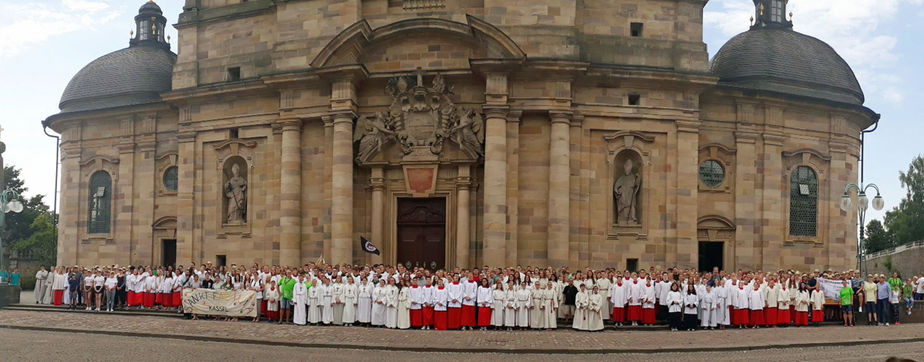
[0, 329, 924, 362]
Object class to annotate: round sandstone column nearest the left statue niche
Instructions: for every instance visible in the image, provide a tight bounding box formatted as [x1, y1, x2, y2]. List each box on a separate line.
[279, 119, 302, 266]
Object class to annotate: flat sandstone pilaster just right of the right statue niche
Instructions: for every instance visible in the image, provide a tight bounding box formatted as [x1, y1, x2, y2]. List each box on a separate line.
[675, 121, 699, 268]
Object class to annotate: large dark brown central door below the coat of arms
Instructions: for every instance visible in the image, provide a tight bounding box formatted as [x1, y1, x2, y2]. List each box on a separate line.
[397, 197, 446, 270]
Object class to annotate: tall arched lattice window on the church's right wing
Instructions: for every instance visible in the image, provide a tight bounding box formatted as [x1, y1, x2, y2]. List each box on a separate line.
[789, 166, 818, 237]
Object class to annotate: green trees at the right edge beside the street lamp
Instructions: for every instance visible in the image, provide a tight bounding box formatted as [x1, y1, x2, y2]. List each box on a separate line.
[884, 155, 924, 245]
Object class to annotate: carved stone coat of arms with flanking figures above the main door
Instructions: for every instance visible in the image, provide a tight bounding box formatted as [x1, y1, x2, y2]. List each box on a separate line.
[353, 72, 484, 163]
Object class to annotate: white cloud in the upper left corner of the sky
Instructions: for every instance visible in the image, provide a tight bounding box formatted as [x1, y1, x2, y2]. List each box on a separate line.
[0, 0, 119, 60]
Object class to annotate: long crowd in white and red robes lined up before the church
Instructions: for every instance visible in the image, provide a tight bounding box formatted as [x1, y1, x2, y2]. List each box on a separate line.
[28, 263, 924, 331]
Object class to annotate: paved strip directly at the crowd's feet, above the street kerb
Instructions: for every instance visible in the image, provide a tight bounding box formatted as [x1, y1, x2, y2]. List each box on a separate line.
[0, 310, 924, 353]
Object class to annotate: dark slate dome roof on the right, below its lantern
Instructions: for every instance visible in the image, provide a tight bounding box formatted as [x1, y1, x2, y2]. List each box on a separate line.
[712, 27, 864, 105]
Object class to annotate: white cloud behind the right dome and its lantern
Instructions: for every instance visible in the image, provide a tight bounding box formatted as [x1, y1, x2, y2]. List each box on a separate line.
[703, 0, 924, 103]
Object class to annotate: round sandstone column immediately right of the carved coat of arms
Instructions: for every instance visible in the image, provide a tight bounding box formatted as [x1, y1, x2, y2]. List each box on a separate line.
[483, 107, 507, 267]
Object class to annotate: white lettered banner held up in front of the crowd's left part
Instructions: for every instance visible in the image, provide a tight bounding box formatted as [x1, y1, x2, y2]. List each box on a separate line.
[183, 289, 259, 317]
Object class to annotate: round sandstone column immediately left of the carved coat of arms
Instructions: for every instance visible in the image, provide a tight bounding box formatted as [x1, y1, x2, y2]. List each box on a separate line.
[328, 113, 354, 264]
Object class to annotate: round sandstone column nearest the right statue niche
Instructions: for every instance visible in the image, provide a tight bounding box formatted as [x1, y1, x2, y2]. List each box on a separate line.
[547, 112, 571, 268]
